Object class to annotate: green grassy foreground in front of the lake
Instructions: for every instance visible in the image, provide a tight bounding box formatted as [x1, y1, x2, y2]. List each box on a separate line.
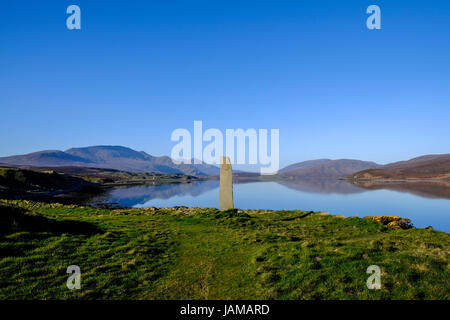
[0, 200, 450, 300]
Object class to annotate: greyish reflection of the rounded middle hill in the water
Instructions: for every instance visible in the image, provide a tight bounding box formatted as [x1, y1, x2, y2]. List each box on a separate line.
[277, 179, 368, 194]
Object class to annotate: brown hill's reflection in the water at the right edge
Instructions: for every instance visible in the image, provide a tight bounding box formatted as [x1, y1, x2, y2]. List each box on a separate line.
[351, 180, 450, 199]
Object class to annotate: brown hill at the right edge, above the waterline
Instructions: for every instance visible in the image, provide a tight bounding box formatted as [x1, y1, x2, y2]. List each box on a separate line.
[350, 154, 450, 180]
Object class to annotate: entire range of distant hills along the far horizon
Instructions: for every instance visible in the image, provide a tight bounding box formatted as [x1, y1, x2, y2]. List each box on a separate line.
[0, 146, 450, 180]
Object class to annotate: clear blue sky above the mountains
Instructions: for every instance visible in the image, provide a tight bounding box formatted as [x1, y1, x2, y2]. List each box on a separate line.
[0, 0, 450, 166]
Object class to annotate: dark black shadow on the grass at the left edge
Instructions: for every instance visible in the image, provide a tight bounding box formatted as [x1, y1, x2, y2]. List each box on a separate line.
[0, 205, 103, 236]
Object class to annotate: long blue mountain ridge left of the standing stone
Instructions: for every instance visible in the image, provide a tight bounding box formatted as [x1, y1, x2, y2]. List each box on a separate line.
[0, 146, 219, 176]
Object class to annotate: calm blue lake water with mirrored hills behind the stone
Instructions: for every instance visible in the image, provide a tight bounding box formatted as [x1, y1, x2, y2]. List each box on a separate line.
[91, 180, 450, 232]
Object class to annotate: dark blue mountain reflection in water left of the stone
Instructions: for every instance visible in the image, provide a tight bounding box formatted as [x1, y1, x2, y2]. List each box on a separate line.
[91, 180, 219, 207]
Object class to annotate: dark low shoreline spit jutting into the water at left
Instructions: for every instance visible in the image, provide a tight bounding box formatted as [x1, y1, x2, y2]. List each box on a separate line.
[0, 166, 200, 204]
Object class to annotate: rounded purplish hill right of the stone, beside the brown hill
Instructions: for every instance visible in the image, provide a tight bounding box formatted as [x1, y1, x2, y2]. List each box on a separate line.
[280, 159, 380, 179]
